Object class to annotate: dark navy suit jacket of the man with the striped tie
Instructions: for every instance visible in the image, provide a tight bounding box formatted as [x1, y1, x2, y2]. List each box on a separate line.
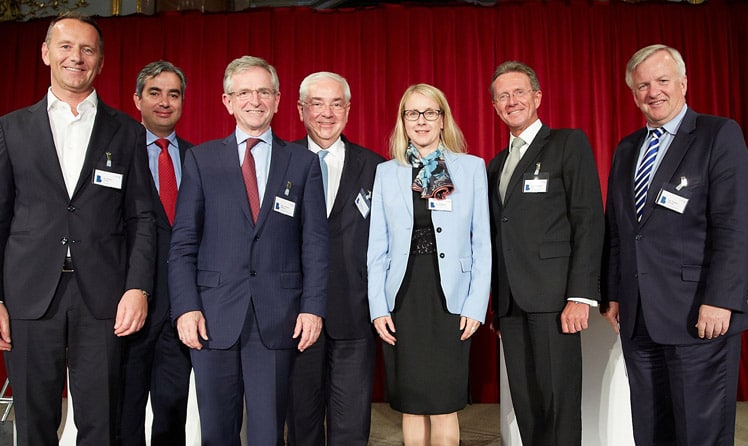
[605, 109, 748, 344]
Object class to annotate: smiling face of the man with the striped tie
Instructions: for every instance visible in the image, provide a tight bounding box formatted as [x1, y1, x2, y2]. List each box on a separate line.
[631, 50, 687, 127]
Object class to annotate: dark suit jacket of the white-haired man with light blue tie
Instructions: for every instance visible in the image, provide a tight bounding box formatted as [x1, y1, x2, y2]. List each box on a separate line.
[296, 136, 384, 339]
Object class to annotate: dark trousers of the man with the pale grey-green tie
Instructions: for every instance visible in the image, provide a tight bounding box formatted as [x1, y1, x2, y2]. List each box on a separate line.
[499, 305, 582, 446]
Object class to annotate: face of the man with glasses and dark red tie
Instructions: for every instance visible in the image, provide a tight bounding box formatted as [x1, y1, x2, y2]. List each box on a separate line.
[222, 67, 280, 136]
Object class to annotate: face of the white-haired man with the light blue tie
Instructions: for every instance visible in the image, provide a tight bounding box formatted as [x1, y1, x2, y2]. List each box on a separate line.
[297, 78, 350, 149]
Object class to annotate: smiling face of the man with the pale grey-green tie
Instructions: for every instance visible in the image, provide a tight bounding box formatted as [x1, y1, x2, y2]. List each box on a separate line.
[491, 71, 542, 136]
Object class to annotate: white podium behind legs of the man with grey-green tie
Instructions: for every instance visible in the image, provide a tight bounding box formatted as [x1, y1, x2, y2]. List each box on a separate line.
[499, 316, 634, 446]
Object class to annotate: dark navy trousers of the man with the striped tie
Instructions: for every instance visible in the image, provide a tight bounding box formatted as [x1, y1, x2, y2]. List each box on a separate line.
[621, 306, 741, 446]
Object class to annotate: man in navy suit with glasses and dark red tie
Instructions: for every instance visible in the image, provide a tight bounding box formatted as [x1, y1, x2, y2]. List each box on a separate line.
[169, 56, 329, 445]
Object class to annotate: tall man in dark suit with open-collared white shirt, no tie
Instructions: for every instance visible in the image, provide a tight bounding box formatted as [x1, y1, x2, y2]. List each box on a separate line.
[0, 16, 155, 446]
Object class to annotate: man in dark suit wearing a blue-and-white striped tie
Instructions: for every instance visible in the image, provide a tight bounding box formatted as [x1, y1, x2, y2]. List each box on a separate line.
[604, 45, 748, 445]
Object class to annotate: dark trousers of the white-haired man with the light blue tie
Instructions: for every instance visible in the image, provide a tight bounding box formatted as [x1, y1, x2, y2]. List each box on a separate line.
[287, 330, 376, 446]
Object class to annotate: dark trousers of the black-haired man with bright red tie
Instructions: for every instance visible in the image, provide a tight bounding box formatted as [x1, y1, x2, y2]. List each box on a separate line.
[119, 318, 192, 446]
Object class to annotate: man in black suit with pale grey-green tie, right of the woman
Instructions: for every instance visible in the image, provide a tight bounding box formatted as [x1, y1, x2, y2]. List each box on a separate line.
[488, 61, 604, 446]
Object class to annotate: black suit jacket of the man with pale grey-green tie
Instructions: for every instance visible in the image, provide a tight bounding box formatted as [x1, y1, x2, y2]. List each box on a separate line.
[488, 126, 604, 317]
